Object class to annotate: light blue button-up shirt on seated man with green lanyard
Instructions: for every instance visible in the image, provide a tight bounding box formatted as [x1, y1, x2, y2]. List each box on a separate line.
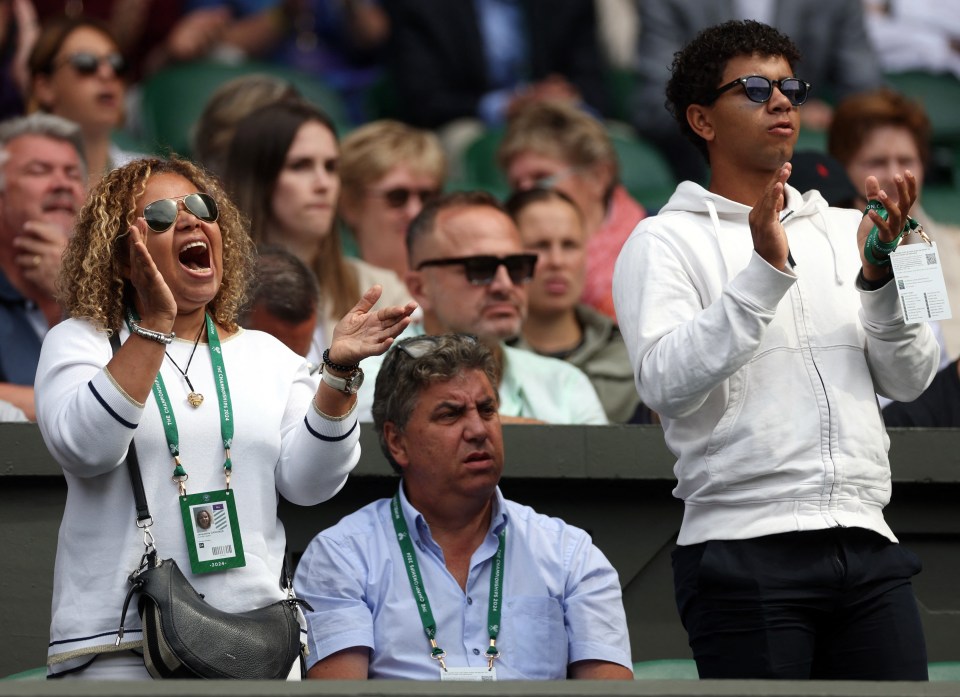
[294, 487, 631, 680]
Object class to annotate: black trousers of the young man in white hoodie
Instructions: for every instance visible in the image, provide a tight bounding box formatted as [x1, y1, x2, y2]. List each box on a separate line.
[673, 528, 927, 680]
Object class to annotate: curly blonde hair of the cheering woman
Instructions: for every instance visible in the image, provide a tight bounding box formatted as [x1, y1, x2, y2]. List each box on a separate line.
[58, 158, 256, 331]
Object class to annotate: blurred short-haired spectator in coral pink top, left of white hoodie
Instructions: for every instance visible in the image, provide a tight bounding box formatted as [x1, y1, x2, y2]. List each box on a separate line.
[497, 103, 646, 320]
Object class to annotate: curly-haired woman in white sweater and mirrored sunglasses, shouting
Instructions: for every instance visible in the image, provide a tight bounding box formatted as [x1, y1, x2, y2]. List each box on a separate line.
[36, 155, 415, 679]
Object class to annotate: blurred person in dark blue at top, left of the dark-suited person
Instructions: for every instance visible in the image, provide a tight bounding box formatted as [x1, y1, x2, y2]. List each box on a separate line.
[185, 0, 390, 124]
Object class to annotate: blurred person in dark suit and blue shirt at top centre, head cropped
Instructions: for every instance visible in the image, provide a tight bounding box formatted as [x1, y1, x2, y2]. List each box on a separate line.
[385, 0, 606, 163]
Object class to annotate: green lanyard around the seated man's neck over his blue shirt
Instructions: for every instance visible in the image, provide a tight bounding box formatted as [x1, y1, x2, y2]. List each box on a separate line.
[390, 491, 507, 671]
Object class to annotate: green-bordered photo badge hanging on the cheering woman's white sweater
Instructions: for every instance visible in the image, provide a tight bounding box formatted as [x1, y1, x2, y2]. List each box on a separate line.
[180, 489, 247, 574]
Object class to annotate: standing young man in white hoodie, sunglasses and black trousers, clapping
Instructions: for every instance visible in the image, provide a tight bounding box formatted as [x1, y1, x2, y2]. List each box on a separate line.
[614, 21, 939, 680]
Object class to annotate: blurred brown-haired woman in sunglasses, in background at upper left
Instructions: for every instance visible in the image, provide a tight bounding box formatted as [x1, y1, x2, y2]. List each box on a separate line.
[30, 17, 137, 188]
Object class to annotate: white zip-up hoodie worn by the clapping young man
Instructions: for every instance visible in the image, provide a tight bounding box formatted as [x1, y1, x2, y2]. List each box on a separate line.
[614, 182, 939, 545]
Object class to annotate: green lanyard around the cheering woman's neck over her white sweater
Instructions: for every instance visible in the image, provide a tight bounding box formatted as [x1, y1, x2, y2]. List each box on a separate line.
[127, 309, 233, 496]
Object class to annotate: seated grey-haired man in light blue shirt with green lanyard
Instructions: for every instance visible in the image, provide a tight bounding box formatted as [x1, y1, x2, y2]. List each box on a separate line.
[294, 334, 632, 680]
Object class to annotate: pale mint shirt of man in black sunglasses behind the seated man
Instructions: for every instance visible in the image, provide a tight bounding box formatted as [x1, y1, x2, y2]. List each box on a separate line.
[357, 322, 609, 425]
